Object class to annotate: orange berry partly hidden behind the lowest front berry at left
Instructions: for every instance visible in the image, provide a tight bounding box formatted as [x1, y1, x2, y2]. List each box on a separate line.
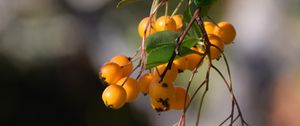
[117, 77, 140, 102]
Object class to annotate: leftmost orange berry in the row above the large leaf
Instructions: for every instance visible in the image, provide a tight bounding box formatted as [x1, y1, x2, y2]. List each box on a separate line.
[138, 17, 155, 38]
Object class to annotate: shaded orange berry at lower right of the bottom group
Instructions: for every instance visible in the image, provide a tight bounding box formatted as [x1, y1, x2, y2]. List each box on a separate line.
[171, 87, 190, 110]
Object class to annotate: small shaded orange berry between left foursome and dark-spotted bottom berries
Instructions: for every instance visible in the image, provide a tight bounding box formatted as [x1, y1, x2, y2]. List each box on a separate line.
[138, 73, 154, 94]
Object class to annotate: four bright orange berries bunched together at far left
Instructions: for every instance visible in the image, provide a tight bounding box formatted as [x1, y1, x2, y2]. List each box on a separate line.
[99, 55, 140, 109]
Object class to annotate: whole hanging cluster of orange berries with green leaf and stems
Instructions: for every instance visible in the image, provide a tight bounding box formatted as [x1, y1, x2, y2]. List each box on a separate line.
[99, 0, 248, 126]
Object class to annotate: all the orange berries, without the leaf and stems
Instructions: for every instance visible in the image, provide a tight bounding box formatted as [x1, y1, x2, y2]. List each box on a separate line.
[99, 15, 236, 112]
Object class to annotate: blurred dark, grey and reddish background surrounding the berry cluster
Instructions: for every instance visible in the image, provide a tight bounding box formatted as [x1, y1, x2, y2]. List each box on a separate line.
[0, 0, 300, 126]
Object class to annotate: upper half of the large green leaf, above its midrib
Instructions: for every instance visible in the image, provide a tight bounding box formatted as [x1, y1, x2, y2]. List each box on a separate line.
[146, 31, 179, 53]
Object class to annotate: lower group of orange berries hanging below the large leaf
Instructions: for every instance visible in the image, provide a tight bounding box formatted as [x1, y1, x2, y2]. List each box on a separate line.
[99, 54, 192, 112]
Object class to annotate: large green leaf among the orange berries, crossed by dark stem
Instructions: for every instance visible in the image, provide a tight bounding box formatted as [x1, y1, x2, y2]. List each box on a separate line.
[146, 31, 198, 69]
